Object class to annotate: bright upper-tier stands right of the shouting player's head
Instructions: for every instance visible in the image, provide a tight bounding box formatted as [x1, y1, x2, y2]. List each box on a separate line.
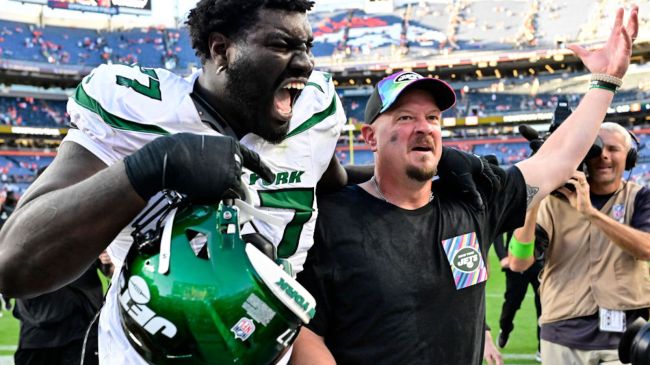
[312, 0, 648, 61]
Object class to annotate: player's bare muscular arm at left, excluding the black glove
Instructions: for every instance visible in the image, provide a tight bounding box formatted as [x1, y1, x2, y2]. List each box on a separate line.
[0, 142, 145, 297]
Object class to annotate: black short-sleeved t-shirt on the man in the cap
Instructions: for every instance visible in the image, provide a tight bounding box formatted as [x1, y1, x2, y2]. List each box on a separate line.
[298, 168, 526, 365]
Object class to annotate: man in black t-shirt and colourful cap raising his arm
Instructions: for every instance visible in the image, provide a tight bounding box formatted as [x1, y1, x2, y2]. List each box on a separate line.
[292, 11, 637, 365]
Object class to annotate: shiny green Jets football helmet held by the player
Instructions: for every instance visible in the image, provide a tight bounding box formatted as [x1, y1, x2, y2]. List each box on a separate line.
[118, 192, 316, 365]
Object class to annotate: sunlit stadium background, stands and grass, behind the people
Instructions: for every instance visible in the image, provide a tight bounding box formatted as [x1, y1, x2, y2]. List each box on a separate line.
[0, 0, 650, 365]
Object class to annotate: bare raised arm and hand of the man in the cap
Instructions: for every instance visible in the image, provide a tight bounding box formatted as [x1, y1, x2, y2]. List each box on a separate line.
[517, 6, 638, 207]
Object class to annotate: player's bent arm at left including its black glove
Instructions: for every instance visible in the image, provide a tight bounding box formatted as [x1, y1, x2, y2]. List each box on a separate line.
[0, 133, 273, 297]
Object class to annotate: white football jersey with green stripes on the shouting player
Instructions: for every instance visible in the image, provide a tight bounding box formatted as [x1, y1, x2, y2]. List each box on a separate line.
[64, 65, 345, 364]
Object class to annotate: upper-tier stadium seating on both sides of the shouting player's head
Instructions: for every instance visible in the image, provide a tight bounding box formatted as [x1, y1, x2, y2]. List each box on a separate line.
[0, 0, 650, 69]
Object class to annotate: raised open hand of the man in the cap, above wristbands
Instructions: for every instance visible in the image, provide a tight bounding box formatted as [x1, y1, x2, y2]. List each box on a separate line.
[568, 5, 639, 78]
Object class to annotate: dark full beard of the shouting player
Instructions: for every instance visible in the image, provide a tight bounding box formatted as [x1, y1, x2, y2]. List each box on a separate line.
[226, 58, 289, 144]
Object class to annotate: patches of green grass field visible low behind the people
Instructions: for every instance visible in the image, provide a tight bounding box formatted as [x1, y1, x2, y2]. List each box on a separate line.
[0, 252, 537, 365]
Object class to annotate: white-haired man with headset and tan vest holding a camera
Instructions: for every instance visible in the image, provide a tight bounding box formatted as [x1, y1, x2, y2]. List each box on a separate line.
[510, 122, 650, 364]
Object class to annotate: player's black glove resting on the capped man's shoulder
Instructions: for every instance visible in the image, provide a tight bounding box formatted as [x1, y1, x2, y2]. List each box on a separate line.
[434, 147, 505, 210]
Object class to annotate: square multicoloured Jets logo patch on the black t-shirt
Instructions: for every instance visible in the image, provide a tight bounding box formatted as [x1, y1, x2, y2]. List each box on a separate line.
[442, 232, 487, 290]
